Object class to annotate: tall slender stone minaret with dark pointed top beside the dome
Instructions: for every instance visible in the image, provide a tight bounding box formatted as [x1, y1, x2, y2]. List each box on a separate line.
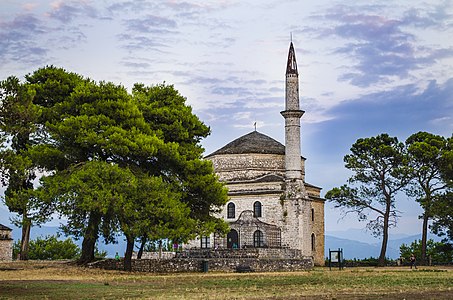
[281, 42, 304, 181]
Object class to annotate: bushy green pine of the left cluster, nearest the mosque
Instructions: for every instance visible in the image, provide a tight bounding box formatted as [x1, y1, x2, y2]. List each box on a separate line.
[115, 84, 227, 269]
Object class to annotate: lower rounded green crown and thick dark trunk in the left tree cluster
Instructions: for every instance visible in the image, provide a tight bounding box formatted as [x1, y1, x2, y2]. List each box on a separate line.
[39, 161, 134, 263]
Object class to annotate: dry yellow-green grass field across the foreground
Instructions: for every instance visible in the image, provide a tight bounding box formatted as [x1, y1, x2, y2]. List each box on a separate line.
[0, 261, 453, 300]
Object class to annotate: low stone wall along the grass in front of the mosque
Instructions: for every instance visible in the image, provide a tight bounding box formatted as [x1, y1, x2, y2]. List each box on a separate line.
[89, 257, 313, 273]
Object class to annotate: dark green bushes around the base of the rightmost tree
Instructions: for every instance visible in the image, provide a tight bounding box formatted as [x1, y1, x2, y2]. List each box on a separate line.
[400, 239, 453, 264]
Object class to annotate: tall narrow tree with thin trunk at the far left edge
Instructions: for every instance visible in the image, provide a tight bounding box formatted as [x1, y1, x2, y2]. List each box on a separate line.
[0, 77, 52, 260]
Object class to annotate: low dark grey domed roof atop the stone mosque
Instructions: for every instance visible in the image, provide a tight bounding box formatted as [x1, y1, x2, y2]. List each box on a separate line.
[206, 131, 285, 157]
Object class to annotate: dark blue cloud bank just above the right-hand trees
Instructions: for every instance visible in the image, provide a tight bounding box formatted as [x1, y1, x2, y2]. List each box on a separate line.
[316, 78, 453, 145]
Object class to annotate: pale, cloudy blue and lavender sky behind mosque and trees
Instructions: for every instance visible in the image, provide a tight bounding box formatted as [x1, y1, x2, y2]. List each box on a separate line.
[0, 0, 453, 241]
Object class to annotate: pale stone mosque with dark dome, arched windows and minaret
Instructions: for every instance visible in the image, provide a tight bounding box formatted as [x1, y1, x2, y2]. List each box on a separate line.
[187, 42, 324, 265]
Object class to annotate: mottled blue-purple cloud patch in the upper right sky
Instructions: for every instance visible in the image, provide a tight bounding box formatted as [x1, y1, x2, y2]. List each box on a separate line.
[310, 5, 453, 87]
